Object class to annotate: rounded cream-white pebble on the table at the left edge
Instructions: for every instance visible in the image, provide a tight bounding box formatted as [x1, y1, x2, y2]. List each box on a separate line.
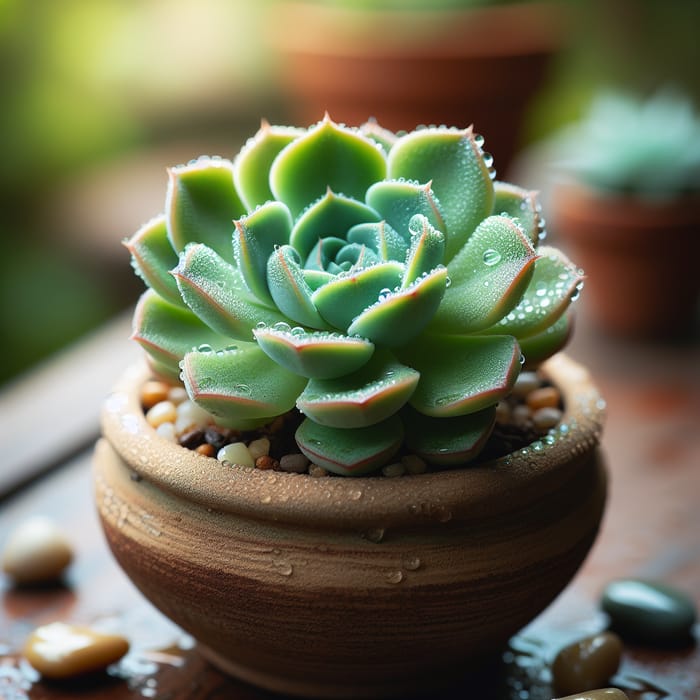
[2, 516, 73, 584]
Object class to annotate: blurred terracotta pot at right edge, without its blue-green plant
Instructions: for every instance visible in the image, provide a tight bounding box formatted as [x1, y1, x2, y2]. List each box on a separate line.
[551, 184, 700, 339]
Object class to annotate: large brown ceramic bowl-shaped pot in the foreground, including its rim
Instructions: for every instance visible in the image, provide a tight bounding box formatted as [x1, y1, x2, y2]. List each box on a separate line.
[94, 355, 606, 698]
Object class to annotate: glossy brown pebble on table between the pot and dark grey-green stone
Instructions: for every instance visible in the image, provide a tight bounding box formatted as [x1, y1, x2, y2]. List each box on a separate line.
[552, 632, 622, 693]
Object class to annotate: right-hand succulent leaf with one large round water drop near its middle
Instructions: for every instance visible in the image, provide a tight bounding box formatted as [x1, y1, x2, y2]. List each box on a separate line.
[432, 216, 537, 333]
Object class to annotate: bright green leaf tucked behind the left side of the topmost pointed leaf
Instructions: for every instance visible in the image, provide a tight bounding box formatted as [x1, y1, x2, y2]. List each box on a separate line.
[233, 120, 304, 211]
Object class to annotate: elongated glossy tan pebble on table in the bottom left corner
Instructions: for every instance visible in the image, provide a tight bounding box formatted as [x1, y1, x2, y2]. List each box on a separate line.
[24, 622, 129, 678]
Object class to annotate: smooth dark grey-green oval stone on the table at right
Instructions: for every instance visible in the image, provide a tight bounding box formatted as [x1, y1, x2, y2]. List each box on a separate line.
[601, 579, 697, 646]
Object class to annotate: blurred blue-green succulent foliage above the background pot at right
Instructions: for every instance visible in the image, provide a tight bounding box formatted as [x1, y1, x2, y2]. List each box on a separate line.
[555, 89, 700, 198]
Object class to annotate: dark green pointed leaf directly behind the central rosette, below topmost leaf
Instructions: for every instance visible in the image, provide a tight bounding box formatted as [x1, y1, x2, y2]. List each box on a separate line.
[289, 189, 380, 260]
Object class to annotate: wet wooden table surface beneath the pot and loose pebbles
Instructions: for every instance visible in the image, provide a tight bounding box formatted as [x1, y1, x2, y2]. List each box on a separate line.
[0, 300, 700, 700]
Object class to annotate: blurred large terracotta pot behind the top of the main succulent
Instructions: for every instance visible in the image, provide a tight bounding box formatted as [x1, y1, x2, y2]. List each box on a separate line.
[270, 0, 566, 173]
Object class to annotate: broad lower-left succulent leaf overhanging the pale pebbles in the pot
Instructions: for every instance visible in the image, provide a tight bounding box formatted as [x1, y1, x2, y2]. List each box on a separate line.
[182, 342, 306, 429]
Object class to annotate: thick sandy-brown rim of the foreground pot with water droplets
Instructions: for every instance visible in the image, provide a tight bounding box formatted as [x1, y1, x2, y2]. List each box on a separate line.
[97, 353, 605, 527]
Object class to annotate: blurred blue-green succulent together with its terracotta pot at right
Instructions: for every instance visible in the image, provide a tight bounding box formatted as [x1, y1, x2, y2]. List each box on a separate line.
[552, 90, 700, 339]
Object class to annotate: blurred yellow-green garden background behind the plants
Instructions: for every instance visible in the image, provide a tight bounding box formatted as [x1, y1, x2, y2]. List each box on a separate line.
[0, 0, 700, 383]
